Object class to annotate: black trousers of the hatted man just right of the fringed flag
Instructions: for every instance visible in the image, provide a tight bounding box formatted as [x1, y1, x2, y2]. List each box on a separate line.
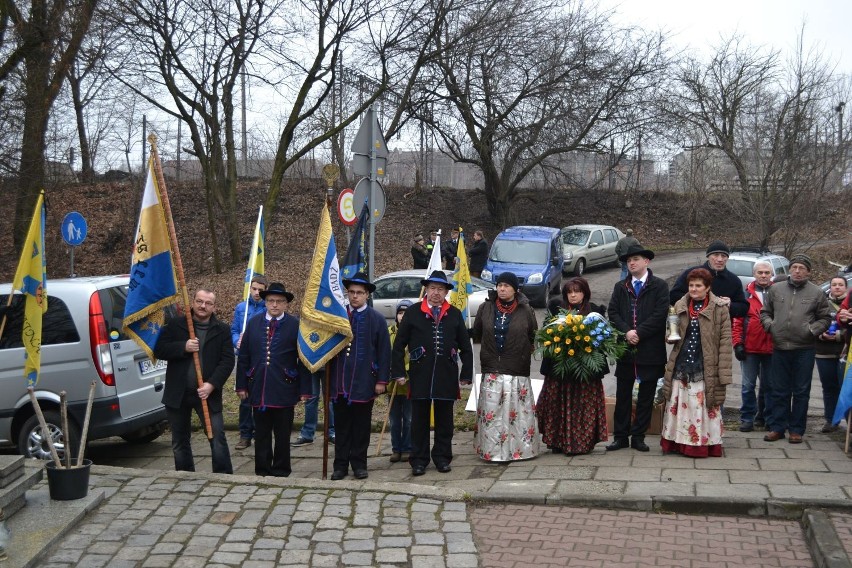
[333, 398, 373, 472]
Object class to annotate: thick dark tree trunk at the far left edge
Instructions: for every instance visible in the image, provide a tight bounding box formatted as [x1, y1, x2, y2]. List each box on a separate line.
[8, 0, 97, 251]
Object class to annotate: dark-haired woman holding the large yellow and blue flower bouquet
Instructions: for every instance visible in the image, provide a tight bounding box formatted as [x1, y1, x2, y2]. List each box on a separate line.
[536, 277, 609, 455]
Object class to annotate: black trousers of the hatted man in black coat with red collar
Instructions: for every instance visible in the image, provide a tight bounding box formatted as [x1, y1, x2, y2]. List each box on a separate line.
[408, 399, 455, 467]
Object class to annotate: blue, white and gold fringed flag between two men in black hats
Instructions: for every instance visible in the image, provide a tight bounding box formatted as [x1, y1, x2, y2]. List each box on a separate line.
[298, 204, 352, 373]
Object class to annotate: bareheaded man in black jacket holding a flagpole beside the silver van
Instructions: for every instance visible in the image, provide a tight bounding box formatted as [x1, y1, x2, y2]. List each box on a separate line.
[154, 289, 234, 473]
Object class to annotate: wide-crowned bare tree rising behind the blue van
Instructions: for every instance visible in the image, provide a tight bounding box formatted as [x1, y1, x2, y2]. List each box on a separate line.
[420, 0, 664, 225]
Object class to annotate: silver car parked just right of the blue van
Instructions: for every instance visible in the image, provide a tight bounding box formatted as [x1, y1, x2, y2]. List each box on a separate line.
[562, 225, 624, 276]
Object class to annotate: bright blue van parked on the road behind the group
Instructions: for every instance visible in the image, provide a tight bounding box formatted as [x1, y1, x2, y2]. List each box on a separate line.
[482, 225, 562, 308]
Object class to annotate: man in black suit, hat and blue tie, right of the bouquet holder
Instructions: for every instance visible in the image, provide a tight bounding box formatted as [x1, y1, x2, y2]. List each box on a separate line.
[606, 245, 669, 452]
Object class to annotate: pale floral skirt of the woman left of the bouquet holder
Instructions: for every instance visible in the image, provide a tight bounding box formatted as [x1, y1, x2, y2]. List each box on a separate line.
[473, 373, 539, 461]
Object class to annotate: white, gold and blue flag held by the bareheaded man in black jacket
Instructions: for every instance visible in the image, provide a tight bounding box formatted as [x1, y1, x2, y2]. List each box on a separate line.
[124, 159, 179, 359]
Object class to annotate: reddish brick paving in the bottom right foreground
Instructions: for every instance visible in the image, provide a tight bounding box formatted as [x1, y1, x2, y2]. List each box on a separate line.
[471, 504, 820, 568]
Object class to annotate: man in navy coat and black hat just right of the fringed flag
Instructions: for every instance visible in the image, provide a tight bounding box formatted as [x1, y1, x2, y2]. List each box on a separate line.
[328, 272, 390, 481]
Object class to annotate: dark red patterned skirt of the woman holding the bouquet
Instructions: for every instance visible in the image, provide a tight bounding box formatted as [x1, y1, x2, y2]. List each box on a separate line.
[536, 370, 607, 454]
